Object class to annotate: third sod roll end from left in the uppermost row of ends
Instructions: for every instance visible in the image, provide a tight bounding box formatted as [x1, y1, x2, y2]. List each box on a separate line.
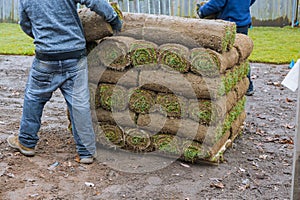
[158, 43, 190, 72]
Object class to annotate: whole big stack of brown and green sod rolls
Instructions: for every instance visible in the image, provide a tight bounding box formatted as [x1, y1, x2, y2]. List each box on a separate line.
[77, 11, 253, 162]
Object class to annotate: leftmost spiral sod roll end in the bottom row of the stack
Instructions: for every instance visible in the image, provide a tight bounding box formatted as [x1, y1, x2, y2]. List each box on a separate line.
[96, 124, 125, 148]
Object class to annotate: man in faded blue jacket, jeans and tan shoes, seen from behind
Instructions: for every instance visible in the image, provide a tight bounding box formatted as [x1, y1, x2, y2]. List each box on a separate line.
[7, 0, 122, 164]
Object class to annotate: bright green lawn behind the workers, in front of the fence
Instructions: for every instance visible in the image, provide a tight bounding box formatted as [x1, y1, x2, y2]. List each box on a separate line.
[0, 23, 300, 64]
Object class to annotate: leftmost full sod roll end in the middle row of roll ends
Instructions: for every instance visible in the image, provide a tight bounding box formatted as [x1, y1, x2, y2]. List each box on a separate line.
[95, 83, 128, 111]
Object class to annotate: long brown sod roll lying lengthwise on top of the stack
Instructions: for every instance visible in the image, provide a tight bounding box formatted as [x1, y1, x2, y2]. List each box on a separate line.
[120, 12, 236, 52]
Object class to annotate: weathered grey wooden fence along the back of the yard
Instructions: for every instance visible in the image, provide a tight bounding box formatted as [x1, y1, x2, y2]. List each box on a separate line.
[0, 0, 300, 26]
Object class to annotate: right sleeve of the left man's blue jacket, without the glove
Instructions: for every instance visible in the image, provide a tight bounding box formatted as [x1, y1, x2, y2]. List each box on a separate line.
[75, 0, 117, 22]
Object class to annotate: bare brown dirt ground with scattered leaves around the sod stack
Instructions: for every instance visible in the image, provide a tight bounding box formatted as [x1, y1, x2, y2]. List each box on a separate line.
[0, 56, 297, 200]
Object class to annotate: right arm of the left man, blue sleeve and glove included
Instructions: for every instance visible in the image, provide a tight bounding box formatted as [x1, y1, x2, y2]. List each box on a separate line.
[75, 0, 122, 32]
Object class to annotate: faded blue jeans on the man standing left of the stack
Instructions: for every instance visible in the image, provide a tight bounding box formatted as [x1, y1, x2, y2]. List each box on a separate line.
[19, 57, 96, 158]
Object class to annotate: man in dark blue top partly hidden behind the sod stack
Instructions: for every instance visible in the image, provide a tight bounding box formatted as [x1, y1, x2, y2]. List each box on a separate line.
[198, 0, 255, 96]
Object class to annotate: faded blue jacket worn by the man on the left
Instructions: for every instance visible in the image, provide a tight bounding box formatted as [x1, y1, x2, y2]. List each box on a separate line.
[19, 0, 117, 54]
